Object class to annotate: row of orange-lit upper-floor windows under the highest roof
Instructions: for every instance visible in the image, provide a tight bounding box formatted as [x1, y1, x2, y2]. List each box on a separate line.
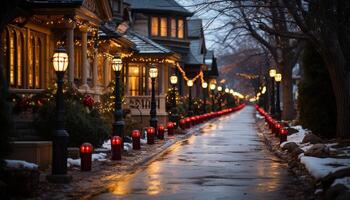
[150, 16, 185, 39]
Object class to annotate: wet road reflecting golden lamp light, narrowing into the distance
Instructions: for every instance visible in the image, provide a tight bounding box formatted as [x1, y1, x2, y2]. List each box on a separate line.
[94, 106, 300, 200]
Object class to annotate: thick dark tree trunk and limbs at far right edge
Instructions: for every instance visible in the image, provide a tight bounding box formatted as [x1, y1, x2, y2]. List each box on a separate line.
[282, 0, 350, 139]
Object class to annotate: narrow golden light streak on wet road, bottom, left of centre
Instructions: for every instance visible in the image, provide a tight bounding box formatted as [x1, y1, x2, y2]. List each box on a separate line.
[145, 162, 163, 195]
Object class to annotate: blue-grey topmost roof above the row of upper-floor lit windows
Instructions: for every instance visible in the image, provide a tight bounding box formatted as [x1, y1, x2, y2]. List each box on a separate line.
[124, 0, 193, 16]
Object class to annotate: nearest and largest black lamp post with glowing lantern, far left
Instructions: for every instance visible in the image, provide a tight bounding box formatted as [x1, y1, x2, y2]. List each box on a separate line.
[47, 47, 72, 183]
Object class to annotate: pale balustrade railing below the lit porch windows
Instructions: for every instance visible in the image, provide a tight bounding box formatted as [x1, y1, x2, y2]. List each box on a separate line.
[125, 95, 166, 115]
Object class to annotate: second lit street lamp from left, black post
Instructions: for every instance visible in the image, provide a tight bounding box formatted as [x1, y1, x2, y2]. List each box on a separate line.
[112, 55, 124, 149]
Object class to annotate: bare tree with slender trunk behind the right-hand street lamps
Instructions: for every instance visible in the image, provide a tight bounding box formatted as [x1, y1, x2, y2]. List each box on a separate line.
[187, 0, 307, 120]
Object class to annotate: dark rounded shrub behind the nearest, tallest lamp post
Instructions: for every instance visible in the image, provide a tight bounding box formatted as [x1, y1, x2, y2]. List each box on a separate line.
[34, 87, 111, 147]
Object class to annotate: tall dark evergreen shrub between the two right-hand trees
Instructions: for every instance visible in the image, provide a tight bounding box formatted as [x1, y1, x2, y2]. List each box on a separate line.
[298, 45, 336, 138]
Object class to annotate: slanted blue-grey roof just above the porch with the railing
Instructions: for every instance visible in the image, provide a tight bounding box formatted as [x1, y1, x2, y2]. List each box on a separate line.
[123, 30, 173, 54]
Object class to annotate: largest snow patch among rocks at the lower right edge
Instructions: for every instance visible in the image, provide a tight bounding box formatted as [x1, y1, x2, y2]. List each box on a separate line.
[300, 155, 350, 179]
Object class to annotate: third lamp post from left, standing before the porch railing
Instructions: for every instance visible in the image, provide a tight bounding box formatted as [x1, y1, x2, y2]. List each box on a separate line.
[149, 65, 158, 130]
